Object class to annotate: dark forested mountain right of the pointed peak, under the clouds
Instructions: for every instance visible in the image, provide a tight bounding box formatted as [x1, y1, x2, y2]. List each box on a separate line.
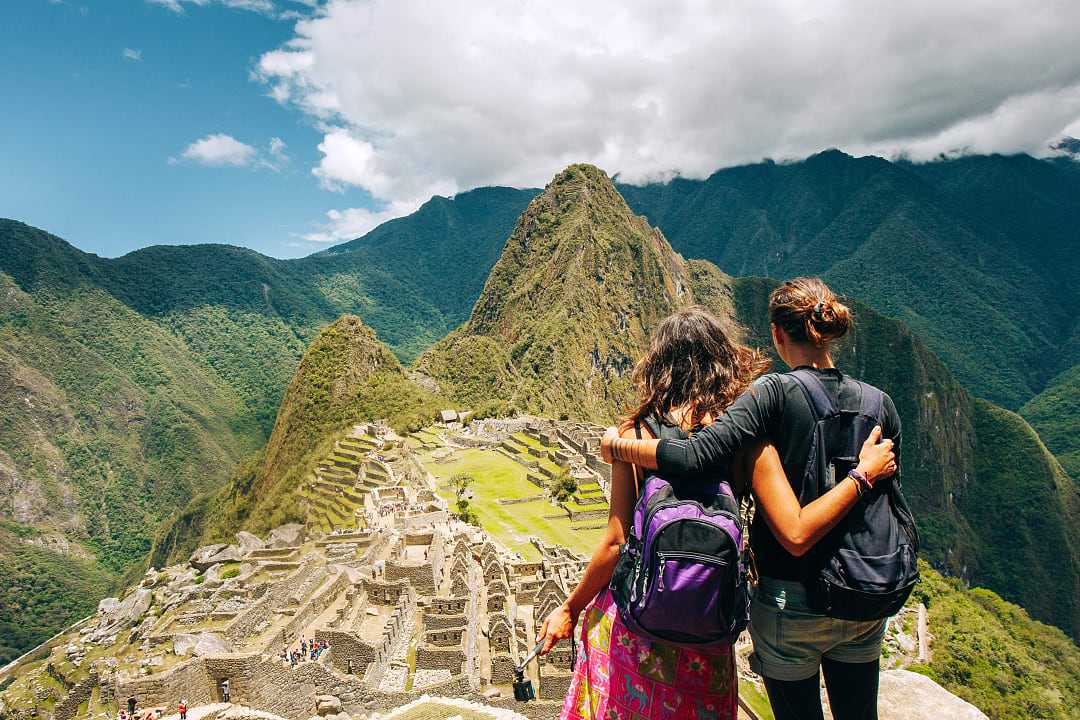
[619, 150, 1080, 409]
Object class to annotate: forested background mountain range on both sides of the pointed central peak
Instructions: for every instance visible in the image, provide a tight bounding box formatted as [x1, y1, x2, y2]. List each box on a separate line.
[0, 151, 1080, 660]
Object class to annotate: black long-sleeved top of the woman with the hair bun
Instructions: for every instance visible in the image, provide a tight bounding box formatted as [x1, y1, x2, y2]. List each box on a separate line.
[657, 367, 901, 580]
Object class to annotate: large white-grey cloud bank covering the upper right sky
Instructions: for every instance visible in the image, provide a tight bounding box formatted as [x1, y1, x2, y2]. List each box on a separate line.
[255, 0, 1080, 234]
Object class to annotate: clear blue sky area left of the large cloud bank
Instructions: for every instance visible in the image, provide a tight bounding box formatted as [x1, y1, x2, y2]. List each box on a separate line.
[0, 0, 378, 257]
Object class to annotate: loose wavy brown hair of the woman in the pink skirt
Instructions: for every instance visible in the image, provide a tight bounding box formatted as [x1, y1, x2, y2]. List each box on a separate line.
[630, 305, 769, 425]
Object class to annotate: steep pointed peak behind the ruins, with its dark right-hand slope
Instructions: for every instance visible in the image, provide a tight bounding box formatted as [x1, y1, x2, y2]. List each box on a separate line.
[417, 165, 1080, 637]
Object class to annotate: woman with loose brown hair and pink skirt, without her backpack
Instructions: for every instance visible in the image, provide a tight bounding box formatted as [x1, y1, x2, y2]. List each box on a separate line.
[540, 307, 891, 720]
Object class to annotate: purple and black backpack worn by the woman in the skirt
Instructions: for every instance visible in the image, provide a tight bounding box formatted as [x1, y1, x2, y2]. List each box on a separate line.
[611, 418, 750, 649]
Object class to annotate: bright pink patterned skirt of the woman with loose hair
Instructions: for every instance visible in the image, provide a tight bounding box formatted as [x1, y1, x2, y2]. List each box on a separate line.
[559, 589, 739, 720]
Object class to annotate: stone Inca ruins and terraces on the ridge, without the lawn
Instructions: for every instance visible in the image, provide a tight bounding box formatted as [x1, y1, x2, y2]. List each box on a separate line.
[5, 412, 609, 720]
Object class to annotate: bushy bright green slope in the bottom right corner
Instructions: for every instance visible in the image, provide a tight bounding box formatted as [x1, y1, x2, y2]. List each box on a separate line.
[910, 563, 1080, 720]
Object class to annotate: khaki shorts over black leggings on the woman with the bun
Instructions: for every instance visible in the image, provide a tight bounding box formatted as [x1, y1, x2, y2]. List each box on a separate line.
[750, 578, 888, 681]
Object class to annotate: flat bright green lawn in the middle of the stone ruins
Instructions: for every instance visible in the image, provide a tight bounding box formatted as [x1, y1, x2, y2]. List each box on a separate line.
[421, 448, 602, 559]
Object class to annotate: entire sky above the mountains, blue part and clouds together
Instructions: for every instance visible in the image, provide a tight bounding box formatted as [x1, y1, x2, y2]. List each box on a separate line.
[0, 0, 1080, 262]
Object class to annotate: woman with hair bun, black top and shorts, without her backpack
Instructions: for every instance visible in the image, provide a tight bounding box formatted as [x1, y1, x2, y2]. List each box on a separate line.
[602, 277, 900, 720]
